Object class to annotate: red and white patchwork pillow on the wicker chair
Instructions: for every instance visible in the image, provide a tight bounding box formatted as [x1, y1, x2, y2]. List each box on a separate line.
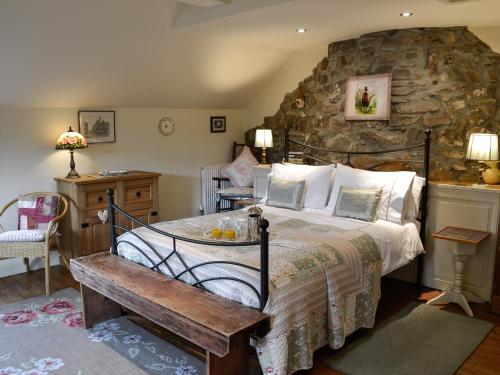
[17, 195, 59, 230]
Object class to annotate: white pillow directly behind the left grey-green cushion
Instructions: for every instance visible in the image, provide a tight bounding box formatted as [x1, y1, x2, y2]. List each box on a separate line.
[271, 163, 335, 209]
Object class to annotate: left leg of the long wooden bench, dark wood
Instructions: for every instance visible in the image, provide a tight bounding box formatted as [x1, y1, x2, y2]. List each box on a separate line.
[80, 284, 122, 329]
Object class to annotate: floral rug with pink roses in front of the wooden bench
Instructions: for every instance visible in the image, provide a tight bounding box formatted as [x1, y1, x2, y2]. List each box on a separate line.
[0, 289, 205, 375]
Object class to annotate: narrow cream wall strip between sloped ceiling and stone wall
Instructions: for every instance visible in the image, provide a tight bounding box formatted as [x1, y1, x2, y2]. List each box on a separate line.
[246, 45, 328, 129]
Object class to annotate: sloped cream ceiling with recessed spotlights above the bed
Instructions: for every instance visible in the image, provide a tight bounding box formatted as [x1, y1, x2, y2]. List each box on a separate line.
[0, 0, 500, 108]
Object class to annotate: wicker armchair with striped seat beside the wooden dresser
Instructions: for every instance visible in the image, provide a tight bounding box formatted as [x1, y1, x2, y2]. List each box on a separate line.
[0, 192, 69, 296]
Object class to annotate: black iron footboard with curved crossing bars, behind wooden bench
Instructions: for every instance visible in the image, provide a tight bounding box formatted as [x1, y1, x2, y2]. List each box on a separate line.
[108, 189, 269, 311]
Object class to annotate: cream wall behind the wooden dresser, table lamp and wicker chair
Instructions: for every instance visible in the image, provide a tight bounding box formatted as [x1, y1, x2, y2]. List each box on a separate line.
[0, 108, 245, 276]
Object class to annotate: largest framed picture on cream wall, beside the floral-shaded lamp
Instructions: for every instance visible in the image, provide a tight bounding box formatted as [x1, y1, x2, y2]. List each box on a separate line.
[78, 111, 116, 143]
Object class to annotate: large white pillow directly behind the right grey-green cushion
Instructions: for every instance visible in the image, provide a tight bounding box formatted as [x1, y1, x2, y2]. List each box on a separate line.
[327, 164, 416, 224]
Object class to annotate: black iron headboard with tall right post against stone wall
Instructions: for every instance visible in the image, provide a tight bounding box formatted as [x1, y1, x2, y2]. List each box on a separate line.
[284, 128, 431, 287]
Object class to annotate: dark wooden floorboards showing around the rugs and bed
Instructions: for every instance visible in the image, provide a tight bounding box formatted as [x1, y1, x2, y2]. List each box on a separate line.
[0, 266, 500, 375]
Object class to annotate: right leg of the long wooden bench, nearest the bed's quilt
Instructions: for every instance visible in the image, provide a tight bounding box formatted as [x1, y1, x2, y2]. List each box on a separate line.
[206, 334, 250, 375]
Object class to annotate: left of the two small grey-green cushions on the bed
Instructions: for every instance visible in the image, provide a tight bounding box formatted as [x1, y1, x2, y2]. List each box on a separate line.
[266, 177, 306, 211]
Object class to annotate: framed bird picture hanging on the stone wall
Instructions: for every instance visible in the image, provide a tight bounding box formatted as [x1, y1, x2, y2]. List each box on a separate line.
[344, 73, 392, 120]
